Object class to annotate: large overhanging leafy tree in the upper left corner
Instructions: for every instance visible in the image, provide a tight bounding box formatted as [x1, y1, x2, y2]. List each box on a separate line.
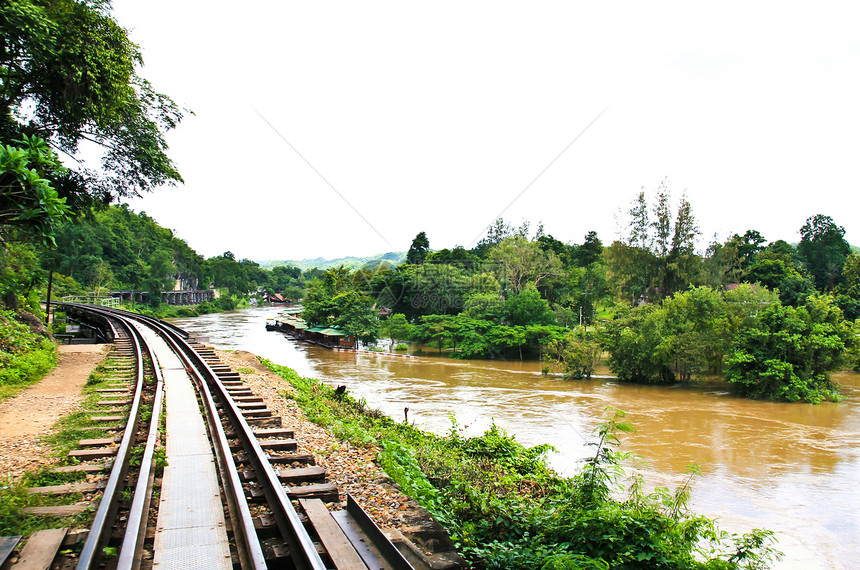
[0, 0, 182, 206]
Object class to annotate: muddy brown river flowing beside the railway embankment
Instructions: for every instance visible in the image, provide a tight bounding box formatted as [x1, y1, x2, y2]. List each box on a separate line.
[174, 307, 860, 570]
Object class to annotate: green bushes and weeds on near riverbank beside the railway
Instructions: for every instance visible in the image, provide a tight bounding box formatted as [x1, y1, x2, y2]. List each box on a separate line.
[264, 361, 780, 570]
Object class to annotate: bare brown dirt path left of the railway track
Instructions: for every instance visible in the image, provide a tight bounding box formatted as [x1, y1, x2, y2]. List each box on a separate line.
[0, 344, 108, 480]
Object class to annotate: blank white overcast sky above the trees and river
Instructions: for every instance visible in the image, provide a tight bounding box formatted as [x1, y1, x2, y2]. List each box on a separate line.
[114, 0, 860, 260]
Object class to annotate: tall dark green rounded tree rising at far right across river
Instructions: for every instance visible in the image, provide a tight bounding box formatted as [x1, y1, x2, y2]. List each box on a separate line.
[797, 214, 851, 291]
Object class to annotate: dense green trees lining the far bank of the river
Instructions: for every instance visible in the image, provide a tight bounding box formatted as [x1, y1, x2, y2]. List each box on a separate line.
[294, 186, 860, 402]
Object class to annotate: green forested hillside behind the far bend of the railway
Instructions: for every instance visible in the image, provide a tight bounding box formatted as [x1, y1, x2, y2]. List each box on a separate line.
[0, 205, 320, 308]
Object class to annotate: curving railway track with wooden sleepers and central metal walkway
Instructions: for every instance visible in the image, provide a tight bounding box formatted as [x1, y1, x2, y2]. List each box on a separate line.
[5, 305, 422, 570]
